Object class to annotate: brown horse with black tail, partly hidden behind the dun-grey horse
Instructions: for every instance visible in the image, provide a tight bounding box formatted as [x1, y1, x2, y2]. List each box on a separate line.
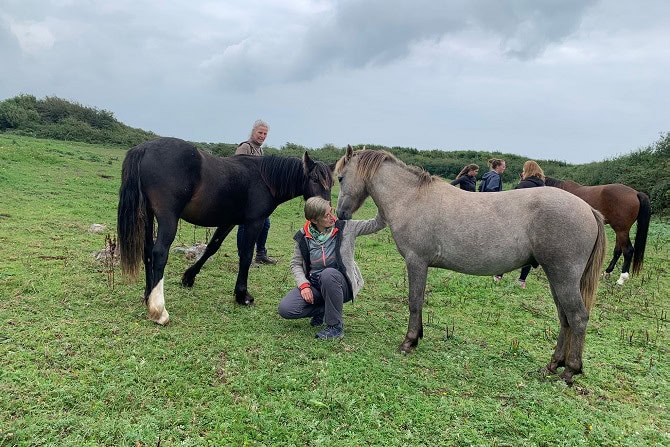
[545, 177, 651, 285]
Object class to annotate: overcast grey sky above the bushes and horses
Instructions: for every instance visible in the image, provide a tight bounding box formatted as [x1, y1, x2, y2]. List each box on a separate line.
[0, 0, 670, 163]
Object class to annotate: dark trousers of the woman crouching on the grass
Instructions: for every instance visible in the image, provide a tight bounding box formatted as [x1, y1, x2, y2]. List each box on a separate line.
[279, 268, 352, 326]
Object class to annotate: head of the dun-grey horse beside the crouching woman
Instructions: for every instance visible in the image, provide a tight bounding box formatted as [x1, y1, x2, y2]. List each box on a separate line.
[335, 145, 368, 220]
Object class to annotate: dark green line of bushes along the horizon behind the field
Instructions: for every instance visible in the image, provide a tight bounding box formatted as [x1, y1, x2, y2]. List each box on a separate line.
[0, 94, 670, 215]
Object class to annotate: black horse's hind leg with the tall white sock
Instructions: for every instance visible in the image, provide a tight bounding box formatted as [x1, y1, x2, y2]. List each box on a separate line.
[146, 218, 177, 325]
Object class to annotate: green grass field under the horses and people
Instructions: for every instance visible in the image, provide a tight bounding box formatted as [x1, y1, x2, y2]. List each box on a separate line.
[0, 134, 670, 446]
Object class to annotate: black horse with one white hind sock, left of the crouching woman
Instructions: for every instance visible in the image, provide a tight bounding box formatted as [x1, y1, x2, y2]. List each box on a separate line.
[118, 138, 333, 324]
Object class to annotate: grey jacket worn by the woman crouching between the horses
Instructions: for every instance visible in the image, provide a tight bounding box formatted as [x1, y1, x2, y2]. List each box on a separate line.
[290, 214, 386, 297]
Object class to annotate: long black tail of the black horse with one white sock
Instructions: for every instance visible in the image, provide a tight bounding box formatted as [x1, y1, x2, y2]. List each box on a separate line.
[117, 147, 147, 279]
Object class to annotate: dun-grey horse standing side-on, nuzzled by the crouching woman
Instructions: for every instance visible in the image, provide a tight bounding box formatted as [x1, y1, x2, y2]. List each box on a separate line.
[336, 146, 606, 383]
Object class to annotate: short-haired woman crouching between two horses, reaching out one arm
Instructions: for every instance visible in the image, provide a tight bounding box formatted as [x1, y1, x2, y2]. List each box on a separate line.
[279, 197, 386, 340]
